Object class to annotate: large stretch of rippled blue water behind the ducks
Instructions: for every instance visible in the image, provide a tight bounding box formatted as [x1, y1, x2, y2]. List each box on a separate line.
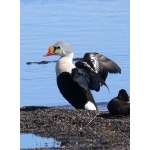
[20, 0, 130, 148]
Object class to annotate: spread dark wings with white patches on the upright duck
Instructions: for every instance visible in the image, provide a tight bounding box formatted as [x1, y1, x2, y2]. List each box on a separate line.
[72, 53, 121, 91]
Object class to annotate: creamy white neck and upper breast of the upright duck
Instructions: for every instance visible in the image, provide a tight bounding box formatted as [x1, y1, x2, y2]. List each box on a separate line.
[56, 53, 75, 76]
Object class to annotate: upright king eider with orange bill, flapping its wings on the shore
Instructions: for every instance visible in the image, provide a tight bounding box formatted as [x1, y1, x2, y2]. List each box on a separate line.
[44, 41, 121, 110]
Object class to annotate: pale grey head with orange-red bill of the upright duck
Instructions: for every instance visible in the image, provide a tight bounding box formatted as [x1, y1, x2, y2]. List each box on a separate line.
[44, 41, 73, 57]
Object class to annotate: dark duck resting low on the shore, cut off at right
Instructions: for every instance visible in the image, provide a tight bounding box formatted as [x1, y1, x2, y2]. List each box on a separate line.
[107, 89, 130, 116]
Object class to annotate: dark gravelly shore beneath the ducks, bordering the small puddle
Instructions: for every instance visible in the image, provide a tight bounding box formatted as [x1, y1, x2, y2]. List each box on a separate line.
[20, 106, 130, 150]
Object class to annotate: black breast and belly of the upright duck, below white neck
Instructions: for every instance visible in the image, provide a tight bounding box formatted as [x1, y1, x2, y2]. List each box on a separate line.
[57, 72, 98, 109]
